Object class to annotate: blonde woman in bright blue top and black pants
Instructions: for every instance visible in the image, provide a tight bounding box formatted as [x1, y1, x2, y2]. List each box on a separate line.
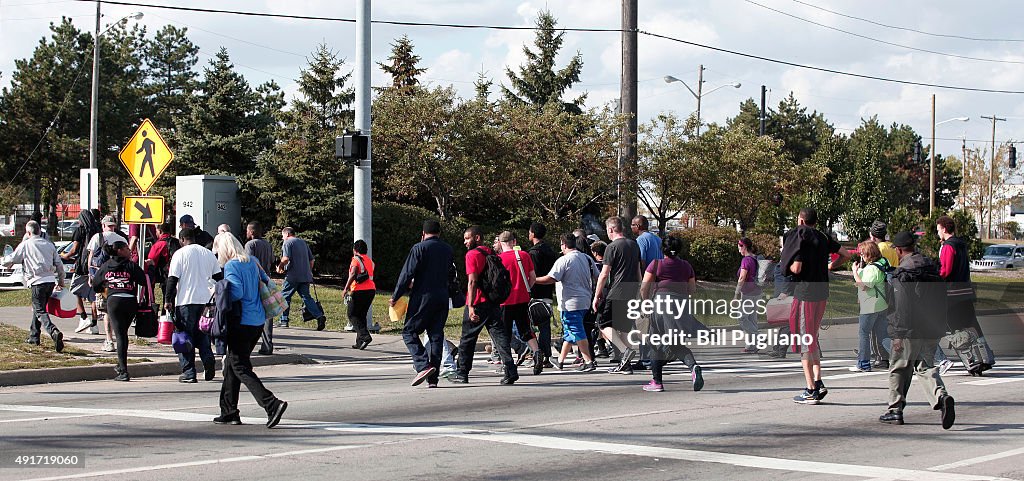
[213, 232, 288, 428]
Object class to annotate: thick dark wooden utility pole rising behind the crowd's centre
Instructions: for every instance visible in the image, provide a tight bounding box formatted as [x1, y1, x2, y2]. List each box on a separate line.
[618, 0, 634, 222]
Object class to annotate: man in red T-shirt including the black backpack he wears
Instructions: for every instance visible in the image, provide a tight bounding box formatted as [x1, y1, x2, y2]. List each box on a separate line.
[449, 225, 519, 386]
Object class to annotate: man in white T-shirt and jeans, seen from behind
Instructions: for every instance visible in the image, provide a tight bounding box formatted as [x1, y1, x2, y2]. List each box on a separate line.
[164, 228, 223, 383]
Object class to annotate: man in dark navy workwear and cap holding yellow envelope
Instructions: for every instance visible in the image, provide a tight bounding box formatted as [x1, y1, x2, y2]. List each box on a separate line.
[390, 220, 452, 388]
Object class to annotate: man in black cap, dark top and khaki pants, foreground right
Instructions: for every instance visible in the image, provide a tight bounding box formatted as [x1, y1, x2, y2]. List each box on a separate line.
[879, 232, 956, 429]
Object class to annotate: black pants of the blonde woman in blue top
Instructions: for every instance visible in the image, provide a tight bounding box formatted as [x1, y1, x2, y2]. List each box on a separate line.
[219, 323, 280, 416]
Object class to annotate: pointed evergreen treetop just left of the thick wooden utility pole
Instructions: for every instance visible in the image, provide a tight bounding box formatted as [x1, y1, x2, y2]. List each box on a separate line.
[502, 10, 587, 114]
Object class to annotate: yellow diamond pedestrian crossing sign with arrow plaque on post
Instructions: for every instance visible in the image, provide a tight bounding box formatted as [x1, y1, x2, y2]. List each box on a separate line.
[118, 119, 174, 271]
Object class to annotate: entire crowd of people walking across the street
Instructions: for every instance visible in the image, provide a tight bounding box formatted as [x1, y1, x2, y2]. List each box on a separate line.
[4, 204, 994, 429]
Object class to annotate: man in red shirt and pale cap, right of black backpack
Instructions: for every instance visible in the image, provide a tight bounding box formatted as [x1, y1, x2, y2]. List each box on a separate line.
[498, 230, 544, 376]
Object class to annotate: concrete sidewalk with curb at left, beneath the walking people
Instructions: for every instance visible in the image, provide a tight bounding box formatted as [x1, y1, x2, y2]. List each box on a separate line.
[0, 307, 409, 387]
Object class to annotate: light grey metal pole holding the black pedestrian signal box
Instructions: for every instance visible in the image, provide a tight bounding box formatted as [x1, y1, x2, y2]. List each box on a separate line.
[356, 0, 380, 331]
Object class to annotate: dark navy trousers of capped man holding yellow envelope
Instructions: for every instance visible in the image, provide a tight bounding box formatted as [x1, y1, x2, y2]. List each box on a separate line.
[401, 296, 448, 384]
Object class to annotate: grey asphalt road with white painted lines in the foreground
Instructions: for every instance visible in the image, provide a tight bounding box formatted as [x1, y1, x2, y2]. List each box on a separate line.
[0, 314, 1024, 481]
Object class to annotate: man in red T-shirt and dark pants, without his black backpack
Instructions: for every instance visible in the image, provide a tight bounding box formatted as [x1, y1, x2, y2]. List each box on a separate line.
[449, 225, 520, 386]
